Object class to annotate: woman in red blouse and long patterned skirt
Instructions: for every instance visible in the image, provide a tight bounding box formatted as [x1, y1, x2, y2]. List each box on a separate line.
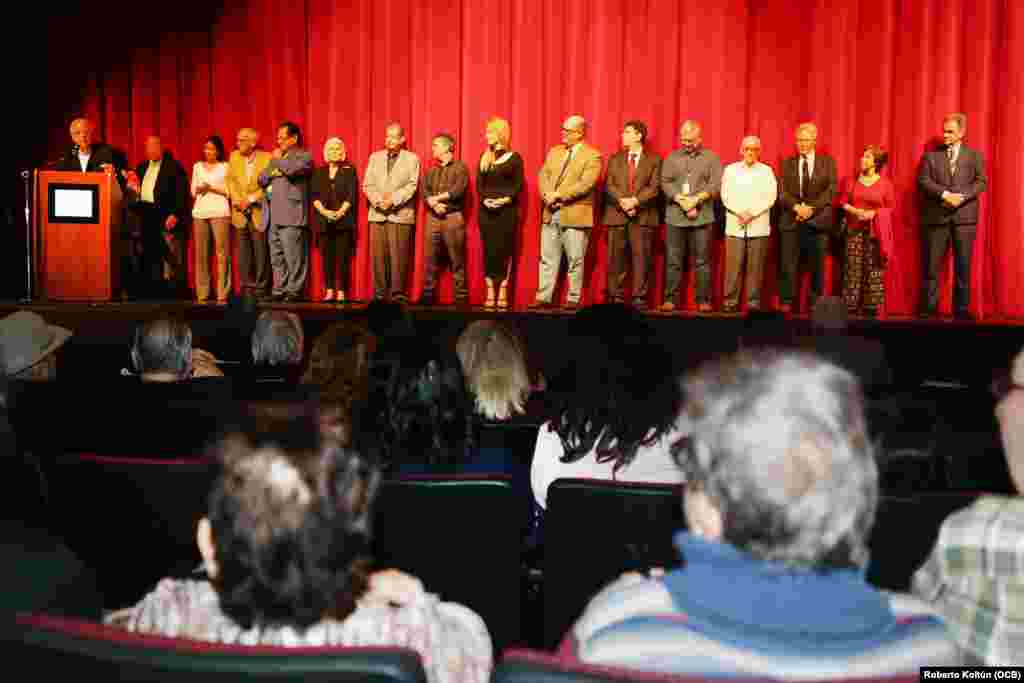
[842, 144, 893, 315]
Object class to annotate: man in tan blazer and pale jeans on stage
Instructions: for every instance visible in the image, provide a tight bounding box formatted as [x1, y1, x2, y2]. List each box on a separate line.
[530, 116, 601, 308]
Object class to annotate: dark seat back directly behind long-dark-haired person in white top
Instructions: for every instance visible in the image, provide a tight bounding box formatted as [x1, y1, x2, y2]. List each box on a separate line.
[544, 479, 686, 647]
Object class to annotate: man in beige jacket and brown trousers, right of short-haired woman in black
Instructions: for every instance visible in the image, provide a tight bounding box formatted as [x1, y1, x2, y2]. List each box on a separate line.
[362, 123, 420, 302]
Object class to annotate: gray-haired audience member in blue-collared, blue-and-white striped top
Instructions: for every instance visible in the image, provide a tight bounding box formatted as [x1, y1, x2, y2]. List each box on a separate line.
[570, 351, 957, 680]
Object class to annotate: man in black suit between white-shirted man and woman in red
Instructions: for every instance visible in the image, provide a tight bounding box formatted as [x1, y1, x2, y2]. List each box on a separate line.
[778, 123, 837, 313]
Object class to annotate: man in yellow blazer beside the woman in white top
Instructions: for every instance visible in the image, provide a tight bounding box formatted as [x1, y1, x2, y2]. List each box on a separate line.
[227, 128, 270, 299]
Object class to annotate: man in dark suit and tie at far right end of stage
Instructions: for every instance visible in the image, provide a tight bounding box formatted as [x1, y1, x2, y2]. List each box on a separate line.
[918, 114, 988, 318]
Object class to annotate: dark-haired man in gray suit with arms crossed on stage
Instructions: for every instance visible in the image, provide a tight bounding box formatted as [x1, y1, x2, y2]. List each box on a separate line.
[259, 121, 313, 301]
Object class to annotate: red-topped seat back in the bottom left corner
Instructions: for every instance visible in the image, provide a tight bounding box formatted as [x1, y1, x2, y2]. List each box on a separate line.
[0, 614, 426, 683]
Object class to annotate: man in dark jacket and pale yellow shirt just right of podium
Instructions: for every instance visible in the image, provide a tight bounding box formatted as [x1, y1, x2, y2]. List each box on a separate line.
[129, 135, 190, 298]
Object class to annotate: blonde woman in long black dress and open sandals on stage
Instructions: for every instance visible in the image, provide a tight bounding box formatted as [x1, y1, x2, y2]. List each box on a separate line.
[476, 117, 523, 308]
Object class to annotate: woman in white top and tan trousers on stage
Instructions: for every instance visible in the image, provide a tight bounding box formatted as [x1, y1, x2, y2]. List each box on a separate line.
[191, 135, 231, 304]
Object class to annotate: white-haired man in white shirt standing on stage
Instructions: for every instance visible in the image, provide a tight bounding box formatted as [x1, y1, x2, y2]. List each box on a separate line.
[721, 135, 778, 312]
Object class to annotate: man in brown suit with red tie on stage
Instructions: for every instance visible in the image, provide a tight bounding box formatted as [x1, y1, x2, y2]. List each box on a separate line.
[603, 121, 662, 308]
